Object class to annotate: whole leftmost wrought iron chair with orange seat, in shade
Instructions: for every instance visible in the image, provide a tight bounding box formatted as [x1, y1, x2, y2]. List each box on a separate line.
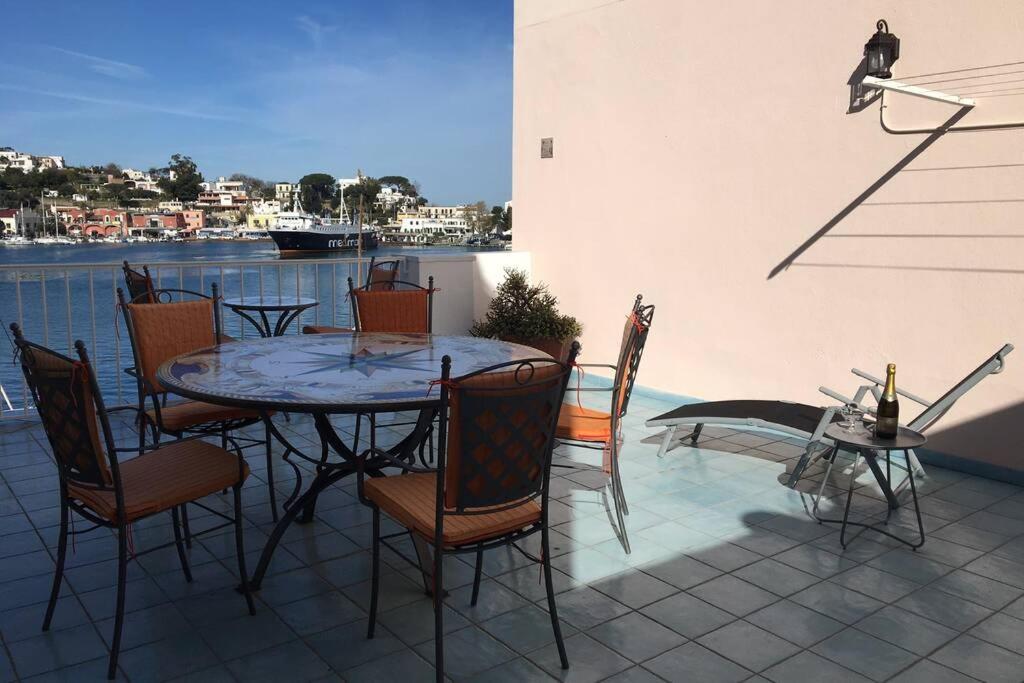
[10, 323, 256, 680]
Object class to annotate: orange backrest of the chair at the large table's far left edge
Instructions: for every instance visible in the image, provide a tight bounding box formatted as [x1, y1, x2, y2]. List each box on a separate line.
[118, 283, 221, 394]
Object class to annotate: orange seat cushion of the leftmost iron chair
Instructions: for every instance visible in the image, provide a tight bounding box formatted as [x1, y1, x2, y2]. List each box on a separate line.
[68, 439, 249, 523]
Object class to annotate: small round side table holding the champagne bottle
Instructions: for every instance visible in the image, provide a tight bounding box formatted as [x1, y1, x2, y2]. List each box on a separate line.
[815, 423, 928, 550]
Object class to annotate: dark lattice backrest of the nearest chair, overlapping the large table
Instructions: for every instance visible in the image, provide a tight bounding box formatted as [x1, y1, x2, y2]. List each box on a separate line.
[437, 344, 580, 514]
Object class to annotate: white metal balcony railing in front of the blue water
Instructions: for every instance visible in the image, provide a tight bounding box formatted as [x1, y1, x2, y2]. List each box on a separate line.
[0, 257, 400, 421]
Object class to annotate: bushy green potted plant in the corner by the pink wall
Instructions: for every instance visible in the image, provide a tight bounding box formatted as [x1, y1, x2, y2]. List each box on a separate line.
[469, 268, 583, 360]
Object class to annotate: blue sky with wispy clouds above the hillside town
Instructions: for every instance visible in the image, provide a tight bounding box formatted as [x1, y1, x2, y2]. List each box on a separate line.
[0, 0, 512, 204]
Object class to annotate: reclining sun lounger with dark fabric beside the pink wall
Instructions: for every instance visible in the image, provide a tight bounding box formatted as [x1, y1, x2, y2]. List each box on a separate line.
[646, 344, 1014, 486]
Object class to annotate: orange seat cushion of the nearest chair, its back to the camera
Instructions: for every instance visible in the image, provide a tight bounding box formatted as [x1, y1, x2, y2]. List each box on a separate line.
[364, 473, 541, 547]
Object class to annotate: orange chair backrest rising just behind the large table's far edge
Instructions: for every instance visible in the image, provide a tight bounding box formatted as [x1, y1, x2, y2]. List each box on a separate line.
[348, 276, 434, 333]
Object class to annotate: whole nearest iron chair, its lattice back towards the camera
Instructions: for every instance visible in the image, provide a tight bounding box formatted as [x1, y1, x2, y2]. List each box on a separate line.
[356, 344, 580, 681]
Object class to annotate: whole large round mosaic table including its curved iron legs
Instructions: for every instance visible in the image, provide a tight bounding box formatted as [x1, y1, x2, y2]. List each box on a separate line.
[157, 333, 547, 590]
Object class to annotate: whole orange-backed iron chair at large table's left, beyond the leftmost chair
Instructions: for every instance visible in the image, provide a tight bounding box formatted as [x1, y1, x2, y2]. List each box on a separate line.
[118, 283, 278, 524]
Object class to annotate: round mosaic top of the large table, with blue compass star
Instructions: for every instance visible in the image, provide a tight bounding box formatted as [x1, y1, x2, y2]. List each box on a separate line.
[157, 333, 550, 413]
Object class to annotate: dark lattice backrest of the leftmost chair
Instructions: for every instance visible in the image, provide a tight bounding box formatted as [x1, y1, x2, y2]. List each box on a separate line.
[10, 323, 117, 488]
